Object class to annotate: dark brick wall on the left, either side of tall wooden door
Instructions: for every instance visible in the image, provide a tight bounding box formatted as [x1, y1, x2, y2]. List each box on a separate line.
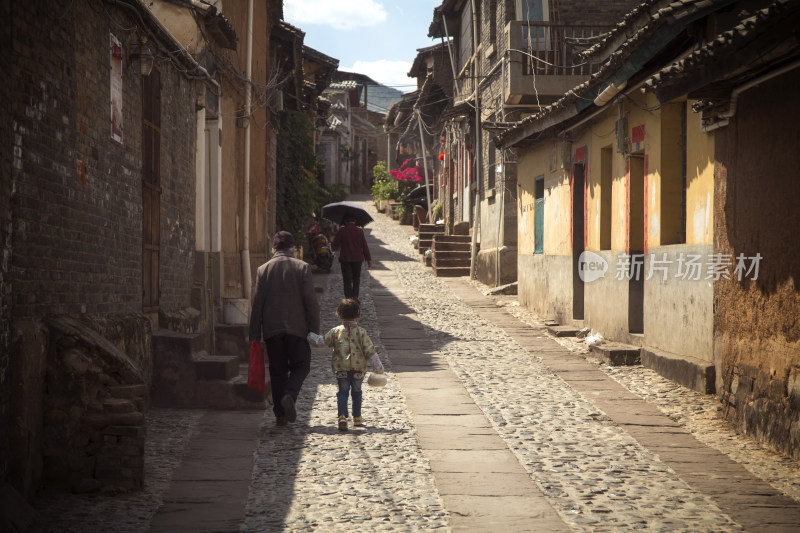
[12, 1, 195, 317]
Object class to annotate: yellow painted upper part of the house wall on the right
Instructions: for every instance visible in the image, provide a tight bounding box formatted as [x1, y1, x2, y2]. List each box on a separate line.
[518, 95, 714, 255]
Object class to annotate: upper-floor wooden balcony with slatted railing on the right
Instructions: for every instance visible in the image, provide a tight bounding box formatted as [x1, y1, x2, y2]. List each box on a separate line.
[503, 20, 611, 107]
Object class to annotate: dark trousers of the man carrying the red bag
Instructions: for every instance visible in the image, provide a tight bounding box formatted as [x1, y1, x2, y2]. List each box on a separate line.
[265, 334, 311, 418]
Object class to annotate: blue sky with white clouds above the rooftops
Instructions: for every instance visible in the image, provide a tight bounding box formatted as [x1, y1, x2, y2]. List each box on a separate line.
[283, 0, 442, 92]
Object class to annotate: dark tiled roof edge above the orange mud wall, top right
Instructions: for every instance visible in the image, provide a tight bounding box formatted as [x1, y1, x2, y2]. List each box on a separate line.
[644, 0, 800, 89]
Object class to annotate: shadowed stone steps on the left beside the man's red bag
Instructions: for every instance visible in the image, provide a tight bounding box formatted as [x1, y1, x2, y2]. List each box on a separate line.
[153, 330, 266, 409]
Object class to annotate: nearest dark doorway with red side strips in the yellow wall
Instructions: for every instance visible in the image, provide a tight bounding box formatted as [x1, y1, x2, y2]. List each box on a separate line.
[628, 152, 645, 333]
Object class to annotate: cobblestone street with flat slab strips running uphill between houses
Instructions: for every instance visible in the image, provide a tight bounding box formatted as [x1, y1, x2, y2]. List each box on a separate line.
[36, 198, 800, 532]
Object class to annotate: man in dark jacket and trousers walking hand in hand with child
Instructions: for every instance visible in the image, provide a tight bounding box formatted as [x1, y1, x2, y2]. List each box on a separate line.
[250, 231, 319, 425]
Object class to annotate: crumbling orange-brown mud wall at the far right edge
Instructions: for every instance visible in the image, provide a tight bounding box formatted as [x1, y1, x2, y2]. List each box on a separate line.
[714, 70, 800, 459]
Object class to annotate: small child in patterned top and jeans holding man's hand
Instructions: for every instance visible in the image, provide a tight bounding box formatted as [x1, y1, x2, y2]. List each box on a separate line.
[323, 298, 384, 431]
